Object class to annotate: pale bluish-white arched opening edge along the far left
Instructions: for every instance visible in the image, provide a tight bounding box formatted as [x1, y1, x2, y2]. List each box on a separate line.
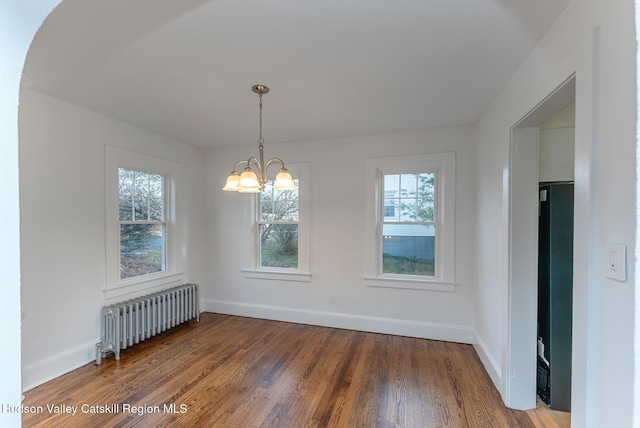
[0, 0, 58, 426]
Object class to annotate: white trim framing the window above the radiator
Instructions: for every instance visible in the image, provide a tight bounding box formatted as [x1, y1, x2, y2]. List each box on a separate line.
[104, 146, 184, 299]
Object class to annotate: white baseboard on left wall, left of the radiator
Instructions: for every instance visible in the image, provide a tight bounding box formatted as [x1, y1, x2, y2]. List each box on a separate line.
[22, 342, 96, 392]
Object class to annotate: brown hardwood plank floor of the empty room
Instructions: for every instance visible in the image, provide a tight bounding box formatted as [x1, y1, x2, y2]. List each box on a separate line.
[23, 313, 548, 428]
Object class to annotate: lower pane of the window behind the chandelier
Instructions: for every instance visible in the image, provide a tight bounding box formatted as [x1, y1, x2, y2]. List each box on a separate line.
[260, 224, 298, 269]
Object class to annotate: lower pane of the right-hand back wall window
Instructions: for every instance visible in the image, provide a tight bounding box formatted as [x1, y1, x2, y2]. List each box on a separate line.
[382, 224, 436, 276]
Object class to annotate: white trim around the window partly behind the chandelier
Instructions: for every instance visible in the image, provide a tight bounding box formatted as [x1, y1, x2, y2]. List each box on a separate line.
[242, 163, 311, 282]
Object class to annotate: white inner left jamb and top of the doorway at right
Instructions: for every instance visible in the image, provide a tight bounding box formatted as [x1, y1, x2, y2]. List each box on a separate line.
[503, 76, 576, 410]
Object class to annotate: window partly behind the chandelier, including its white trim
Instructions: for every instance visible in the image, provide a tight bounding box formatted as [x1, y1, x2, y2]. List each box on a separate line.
[243, 163, 311, 282]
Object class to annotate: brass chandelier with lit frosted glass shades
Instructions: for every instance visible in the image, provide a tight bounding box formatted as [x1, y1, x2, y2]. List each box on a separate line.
[222, 85, 296, 193]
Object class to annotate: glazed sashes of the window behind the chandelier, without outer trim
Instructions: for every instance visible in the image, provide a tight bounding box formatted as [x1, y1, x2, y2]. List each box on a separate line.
[257, 179, 300, 269]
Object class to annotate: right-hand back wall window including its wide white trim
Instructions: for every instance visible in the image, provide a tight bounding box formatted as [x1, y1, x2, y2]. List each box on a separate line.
[365, 153, 455, 291]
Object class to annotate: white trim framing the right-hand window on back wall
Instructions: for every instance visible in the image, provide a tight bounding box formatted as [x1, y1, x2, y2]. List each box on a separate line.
[364, 152, 456, 291]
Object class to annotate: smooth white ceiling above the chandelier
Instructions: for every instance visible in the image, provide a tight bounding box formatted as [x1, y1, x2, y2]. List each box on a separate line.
[24, 0, 570, 147]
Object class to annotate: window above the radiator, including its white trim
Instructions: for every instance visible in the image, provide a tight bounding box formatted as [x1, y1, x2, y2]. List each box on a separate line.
[104, 146, 185, 298]
